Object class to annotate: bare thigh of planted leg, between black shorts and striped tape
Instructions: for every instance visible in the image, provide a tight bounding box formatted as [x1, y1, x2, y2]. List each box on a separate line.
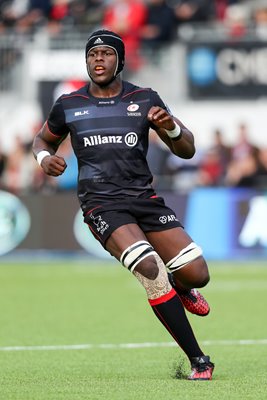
[105, 224, 147, 260]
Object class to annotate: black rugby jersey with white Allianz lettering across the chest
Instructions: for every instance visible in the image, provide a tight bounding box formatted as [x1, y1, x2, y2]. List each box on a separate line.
[47, 81, 166, 208]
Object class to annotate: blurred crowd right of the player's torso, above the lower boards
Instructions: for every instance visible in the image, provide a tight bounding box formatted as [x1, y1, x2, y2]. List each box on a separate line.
[148, 123, 267, 193]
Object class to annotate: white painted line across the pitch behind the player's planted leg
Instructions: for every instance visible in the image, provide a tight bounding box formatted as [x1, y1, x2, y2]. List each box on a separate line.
[0, 339, 267, 351]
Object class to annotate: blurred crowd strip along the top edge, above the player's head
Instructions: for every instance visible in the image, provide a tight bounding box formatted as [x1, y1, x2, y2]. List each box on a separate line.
[0, 0, 267, 48]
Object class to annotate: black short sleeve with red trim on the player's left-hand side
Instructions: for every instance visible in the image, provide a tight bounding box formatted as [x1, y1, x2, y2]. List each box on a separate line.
[47, 98, 69, 137]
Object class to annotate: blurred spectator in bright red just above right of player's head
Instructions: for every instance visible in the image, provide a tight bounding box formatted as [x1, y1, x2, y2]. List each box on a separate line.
[102, 0, 147, 73]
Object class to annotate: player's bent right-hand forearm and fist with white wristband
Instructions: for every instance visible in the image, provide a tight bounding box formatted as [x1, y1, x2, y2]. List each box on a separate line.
[147, 106, 196, 159]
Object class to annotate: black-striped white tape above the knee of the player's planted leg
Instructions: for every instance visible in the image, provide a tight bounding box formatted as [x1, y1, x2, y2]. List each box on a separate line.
[120, 240, 157, 272]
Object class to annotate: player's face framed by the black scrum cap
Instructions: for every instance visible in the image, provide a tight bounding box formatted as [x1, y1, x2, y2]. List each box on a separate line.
[86, 46, 117, 85]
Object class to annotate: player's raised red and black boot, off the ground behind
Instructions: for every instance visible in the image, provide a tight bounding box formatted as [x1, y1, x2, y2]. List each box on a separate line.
[168, 273, 210, 317]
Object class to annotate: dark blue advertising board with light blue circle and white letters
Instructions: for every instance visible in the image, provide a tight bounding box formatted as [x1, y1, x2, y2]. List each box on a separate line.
[186, 41, 267, 100]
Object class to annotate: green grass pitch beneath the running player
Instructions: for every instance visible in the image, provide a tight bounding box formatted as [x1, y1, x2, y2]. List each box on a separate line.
[0, 259, 267, 400]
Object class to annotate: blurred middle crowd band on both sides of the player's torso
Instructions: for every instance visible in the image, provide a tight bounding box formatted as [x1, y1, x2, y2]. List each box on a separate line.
[0, 123, 267, 194]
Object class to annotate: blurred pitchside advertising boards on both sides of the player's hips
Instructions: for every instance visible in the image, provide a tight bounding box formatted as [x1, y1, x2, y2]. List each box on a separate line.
[0, 188, 267, 261]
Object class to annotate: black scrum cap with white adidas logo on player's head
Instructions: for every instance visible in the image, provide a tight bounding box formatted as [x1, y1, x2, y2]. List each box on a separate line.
[85, 29, 125, 76]
